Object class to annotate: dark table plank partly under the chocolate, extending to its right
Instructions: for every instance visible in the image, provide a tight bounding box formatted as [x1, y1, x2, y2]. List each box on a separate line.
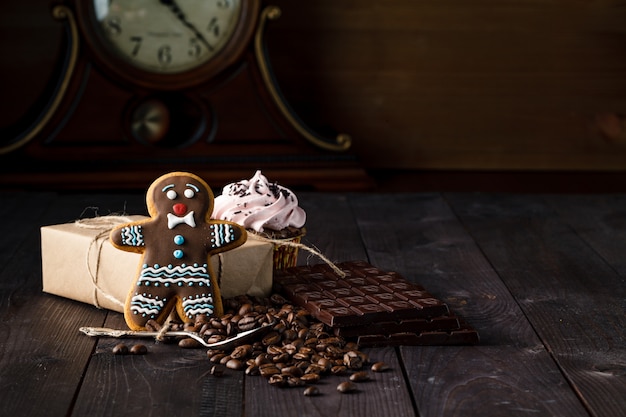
[351, 194, 587, 416]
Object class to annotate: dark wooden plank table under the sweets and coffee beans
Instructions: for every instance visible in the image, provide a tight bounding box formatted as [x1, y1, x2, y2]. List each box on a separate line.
[0, 192, 626, 417]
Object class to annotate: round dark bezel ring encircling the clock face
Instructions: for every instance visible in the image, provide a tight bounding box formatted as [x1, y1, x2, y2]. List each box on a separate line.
[75, 0, 261, 91]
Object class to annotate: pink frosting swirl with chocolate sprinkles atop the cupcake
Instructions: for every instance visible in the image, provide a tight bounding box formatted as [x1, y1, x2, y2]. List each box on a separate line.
[212, 171, 306, 232]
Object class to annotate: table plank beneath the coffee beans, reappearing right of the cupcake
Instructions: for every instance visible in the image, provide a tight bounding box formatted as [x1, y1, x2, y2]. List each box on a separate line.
[245, 193, 415, 417]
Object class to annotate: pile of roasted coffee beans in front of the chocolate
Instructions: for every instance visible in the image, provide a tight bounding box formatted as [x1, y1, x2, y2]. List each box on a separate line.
[153, 294, 388, 395]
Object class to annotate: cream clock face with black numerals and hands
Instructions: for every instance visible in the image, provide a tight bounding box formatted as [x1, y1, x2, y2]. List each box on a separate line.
[92, 0, 247, 74]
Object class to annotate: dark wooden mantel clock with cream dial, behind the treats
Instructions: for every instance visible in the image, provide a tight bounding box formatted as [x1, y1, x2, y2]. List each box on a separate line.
[0, 0, 369, 188]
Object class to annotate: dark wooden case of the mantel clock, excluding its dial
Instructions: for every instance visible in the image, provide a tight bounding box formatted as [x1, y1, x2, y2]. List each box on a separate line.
[0, 0, 371, 190]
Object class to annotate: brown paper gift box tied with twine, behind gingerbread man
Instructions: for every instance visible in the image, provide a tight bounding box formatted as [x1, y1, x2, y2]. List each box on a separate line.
[41, 216, 273, 312]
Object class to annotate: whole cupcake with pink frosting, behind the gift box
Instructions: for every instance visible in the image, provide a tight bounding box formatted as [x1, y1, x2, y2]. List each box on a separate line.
[212, 171, 306, 269]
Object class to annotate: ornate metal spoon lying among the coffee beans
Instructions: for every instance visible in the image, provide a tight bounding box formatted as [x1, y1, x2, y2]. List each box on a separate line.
[78, 323, 274, 349]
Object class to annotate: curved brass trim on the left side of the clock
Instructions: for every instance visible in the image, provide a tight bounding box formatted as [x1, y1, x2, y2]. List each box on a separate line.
[0, 5, 79, 155]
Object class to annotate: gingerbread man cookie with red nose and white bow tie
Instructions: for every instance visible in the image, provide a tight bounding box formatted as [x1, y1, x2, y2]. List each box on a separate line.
[110, 172, 247, 330]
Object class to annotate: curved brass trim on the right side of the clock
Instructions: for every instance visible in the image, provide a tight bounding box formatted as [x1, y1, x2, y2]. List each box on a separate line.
[254, 6, 352, 151]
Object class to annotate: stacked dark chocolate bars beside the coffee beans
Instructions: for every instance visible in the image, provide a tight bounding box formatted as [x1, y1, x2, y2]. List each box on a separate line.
[274, 261, 478, 346]
